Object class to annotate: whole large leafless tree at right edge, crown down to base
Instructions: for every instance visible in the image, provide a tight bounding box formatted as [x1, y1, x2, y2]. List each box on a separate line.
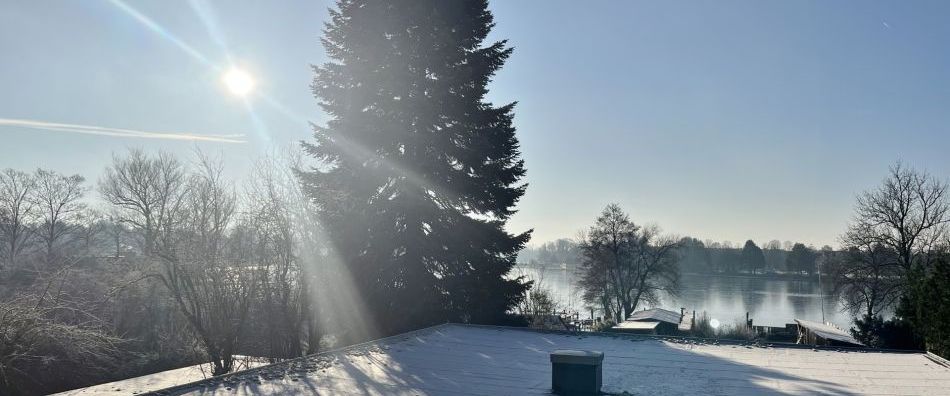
[834, 162, 950, 344]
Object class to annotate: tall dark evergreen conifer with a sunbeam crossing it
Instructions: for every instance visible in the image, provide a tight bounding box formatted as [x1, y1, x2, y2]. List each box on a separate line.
[301, 0, 530, 333]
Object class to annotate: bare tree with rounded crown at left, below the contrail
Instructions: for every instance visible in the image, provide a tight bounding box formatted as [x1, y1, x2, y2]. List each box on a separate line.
[99, 149, 186, 256]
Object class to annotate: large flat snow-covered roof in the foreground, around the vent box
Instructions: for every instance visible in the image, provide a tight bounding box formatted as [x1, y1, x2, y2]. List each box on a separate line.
[121, 324, 950, 395]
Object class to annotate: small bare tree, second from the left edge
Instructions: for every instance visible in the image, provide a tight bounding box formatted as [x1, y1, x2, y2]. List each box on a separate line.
[30, 169, 86, 265]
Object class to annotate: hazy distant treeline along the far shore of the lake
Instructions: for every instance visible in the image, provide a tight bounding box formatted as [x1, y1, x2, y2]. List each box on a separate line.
[518, 237, 836, 275]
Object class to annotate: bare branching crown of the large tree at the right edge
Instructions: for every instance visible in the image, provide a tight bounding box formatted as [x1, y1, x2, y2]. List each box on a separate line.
[849, 162, 950, 271]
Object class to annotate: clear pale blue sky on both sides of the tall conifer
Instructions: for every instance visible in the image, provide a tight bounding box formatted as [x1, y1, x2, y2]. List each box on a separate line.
[0, 0, 950, 246]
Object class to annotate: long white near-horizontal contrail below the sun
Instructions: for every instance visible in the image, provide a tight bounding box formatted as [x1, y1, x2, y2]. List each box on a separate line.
[0, 118, 246, 143]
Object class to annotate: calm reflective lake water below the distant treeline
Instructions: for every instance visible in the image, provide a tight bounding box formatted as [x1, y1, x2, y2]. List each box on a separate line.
[516, 266, 851, 329]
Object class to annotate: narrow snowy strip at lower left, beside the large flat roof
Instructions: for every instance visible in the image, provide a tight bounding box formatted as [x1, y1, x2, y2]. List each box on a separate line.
[56, 356, 267, 396]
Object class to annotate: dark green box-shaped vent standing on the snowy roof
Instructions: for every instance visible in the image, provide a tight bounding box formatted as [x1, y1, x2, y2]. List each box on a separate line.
[551, 349, 604, 395]
